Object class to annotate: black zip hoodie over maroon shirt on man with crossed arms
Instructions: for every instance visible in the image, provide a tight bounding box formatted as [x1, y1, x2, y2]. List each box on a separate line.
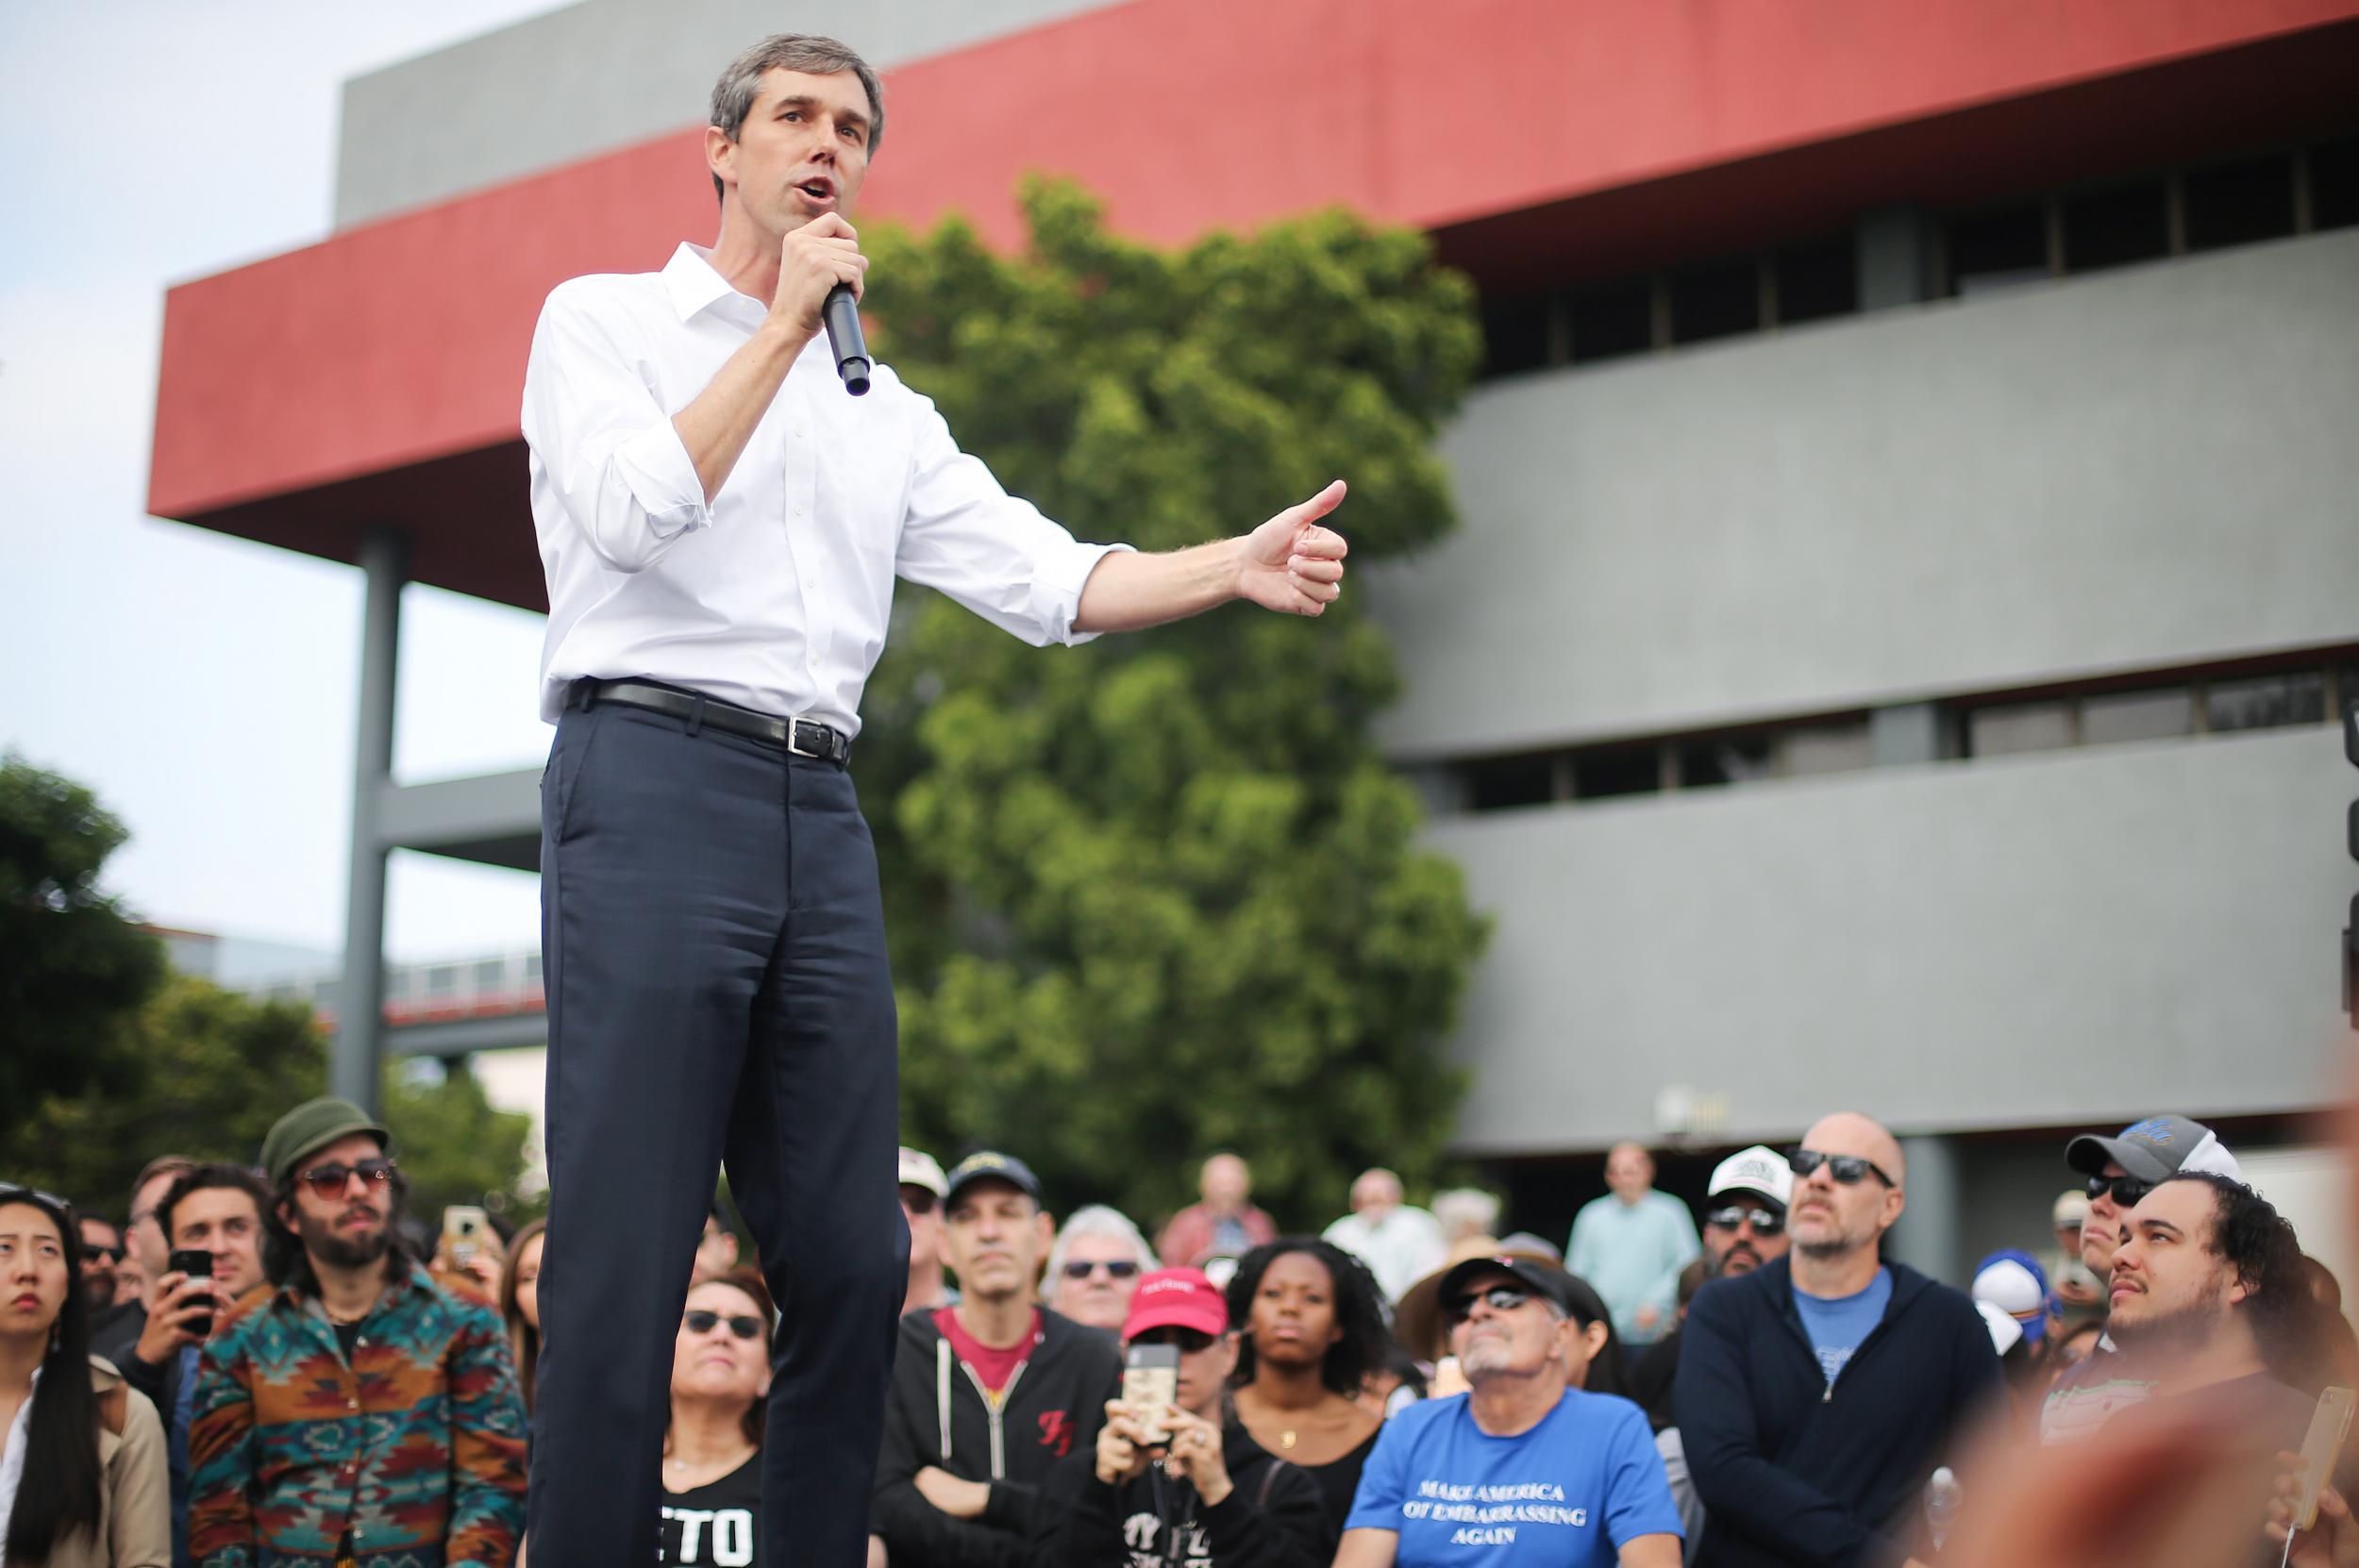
[868, 1307, 1123, 1568]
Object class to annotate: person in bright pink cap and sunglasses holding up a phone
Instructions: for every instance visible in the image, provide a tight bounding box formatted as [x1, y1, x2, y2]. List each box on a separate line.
[1031, 1269, 1335, 1568]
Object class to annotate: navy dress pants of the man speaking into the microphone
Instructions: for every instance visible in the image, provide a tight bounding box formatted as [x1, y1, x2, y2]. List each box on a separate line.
[528, 703, 909, 1568]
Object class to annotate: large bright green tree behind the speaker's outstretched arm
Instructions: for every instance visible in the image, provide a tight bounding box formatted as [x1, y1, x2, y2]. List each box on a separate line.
[862, 181, 1484, 1224]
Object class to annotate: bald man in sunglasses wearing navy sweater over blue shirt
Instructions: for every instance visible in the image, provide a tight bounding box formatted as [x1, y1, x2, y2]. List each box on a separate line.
[1675, 1110, 2000, 1568]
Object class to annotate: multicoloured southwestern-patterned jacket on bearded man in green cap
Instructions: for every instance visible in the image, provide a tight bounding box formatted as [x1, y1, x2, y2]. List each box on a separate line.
[189, 1261, 524, 1568]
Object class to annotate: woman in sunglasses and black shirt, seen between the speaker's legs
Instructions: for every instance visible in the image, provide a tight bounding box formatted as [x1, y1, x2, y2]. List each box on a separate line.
[661, 1247, 777, 1568]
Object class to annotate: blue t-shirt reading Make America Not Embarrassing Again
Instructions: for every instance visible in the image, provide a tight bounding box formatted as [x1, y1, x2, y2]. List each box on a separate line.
[1345, 1389, 1680, 1568]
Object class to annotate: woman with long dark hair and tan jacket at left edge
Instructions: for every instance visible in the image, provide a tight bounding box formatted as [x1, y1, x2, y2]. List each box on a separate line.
[0, 1184, 173, 1568]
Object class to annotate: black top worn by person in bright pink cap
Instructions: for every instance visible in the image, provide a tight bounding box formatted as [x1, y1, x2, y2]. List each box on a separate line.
[1031, 1422, 1335, 1568]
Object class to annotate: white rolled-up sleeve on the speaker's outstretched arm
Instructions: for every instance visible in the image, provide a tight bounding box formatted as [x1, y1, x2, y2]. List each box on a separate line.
[895, 392, 1130, 646]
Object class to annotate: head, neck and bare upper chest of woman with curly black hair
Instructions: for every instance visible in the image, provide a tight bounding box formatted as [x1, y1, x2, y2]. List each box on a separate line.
[1230, 1236, 1392, 1533]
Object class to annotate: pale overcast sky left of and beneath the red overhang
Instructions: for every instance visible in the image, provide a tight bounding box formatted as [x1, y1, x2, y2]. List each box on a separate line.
[0, 0, 571, 959]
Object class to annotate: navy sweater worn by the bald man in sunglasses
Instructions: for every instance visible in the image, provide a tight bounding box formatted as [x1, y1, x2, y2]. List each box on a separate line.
[1675, 1259, 2003, 1568]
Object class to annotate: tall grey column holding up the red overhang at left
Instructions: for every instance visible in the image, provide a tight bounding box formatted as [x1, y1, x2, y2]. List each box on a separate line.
[328, 528, 410, 1115]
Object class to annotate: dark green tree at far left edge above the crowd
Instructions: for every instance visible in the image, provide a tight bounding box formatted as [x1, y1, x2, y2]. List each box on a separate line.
[0, 752, 165, 1145]
